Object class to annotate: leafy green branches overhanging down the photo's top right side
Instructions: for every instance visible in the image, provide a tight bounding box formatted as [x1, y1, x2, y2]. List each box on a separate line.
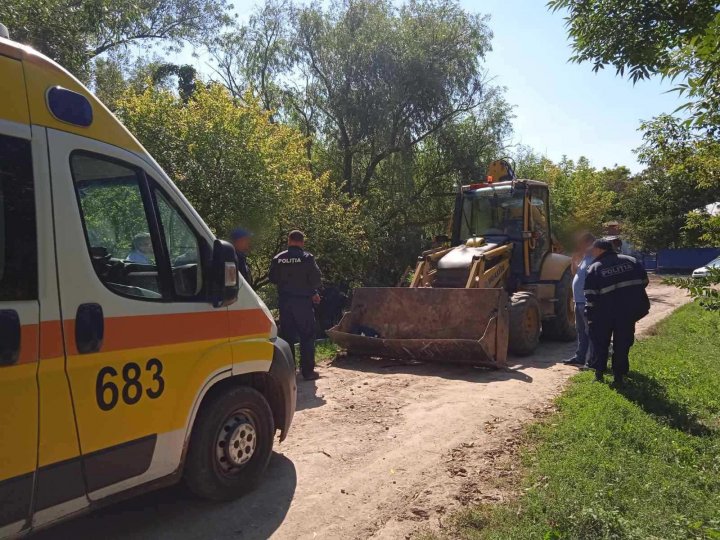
[548, 0, 720, 250]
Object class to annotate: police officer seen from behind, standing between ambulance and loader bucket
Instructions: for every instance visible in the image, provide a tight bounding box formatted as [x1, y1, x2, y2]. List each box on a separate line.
[269, 231, 322, 380]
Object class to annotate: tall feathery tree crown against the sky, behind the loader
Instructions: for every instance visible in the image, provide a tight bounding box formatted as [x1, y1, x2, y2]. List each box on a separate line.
[295, 0, 491, 195]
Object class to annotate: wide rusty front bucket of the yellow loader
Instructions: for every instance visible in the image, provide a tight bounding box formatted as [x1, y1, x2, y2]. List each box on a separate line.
[327, 288, 508, 368]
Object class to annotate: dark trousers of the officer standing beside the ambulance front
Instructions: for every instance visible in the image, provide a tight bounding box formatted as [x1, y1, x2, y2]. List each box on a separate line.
[279, 296, 315, 376]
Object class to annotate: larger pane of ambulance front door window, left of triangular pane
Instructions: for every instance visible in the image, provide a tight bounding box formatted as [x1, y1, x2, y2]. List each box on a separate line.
[70, 152, 163, 300]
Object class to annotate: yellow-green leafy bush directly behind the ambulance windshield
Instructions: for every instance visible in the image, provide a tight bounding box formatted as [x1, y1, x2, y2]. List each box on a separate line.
[119, 85, 367, 294]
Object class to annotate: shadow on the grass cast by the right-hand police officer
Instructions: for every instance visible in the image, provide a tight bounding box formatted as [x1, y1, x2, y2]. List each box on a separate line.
[618, 371, 712, 436]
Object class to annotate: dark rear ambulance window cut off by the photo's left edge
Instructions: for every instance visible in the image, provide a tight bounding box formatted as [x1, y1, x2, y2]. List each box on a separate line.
[0, 135, 38, 301]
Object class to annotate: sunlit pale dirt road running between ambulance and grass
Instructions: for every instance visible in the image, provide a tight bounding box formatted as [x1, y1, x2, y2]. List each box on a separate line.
[42, 281, 687, 540]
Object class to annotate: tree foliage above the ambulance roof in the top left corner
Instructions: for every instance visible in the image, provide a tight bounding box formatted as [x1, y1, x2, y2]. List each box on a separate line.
[0, 0, 229, 80]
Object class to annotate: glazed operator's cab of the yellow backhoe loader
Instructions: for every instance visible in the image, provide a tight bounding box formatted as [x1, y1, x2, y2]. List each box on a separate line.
[452, 180, 552, 282]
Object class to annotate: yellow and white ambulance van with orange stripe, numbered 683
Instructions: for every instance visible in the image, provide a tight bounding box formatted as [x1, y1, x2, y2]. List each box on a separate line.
[0, 26, 296, 538]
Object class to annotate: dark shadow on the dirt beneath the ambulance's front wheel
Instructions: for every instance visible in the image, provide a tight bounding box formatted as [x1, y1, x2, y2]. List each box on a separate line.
[32, 453, 297, 540]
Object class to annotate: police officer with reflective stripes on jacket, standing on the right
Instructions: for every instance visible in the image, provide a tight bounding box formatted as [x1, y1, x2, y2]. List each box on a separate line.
[585, 239, 650, 385]
